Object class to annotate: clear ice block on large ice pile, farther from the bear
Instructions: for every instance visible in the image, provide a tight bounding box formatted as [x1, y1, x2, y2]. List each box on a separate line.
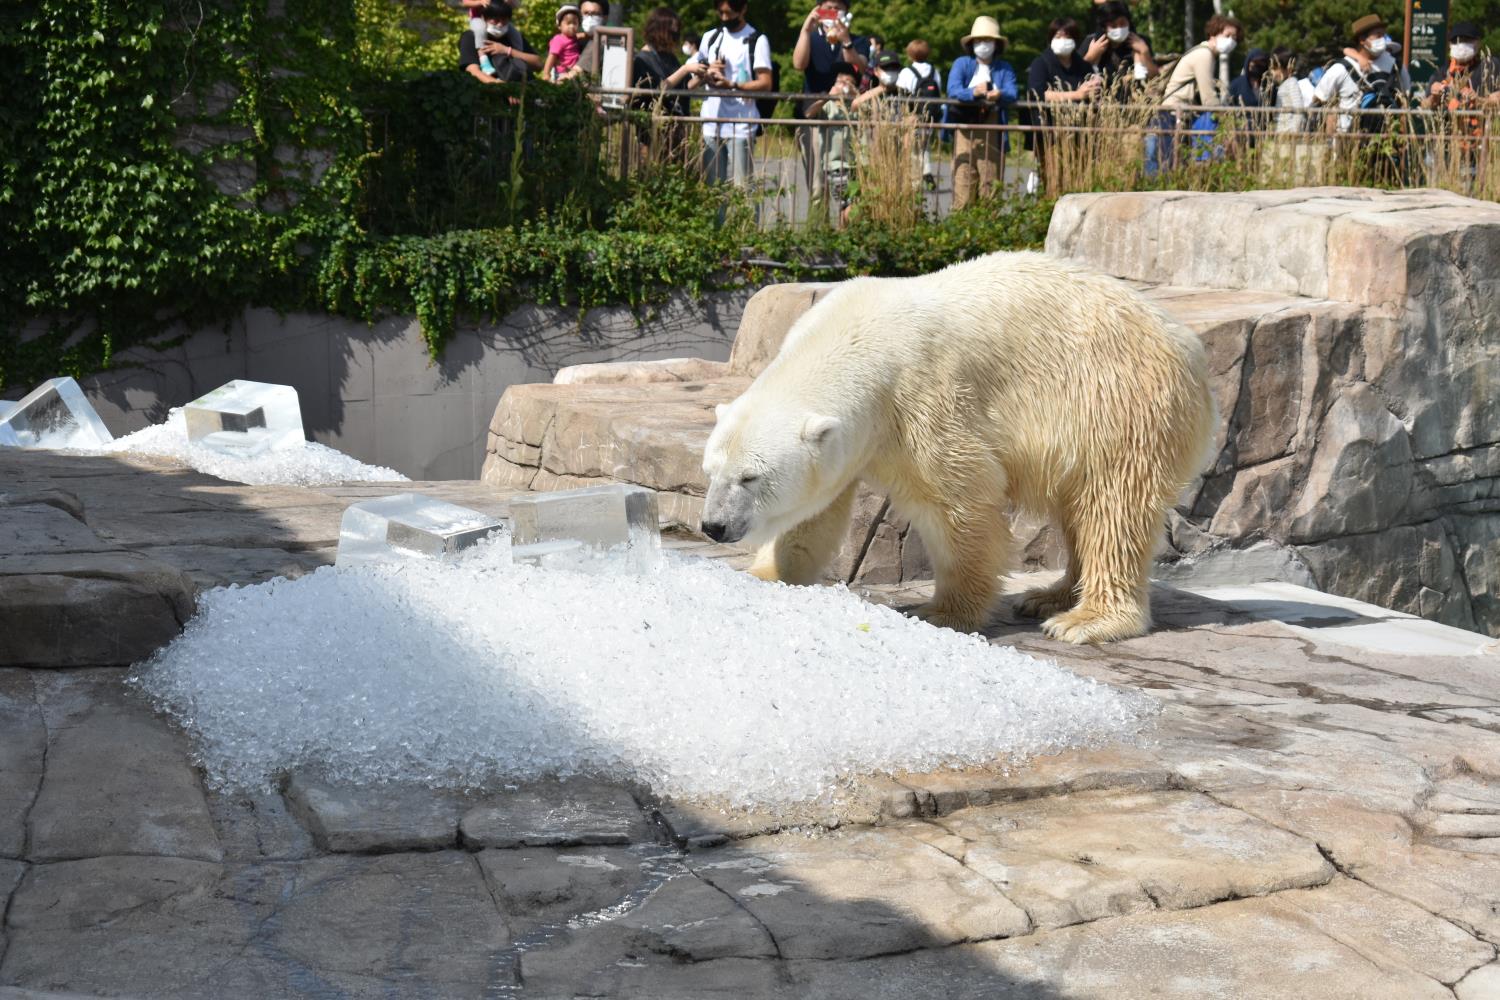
[335, 493, 506, 565]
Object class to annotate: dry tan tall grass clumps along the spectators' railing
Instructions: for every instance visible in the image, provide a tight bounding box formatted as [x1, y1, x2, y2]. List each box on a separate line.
[605, 90, 1500, 231]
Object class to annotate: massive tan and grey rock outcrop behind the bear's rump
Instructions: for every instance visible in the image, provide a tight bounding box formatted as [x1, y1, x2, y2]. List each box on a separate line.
[1047, 189, 1500, 634]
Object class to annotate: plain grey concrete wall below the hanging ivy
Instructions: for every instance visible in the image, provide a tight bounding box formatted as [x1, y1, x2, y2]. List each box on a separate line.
[61, 289, 753, 480]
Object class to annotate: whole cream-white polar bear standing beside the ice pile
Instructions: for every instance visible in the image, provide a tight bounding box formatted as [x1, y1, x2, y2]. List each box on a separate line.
[702, 253, 1215, 642]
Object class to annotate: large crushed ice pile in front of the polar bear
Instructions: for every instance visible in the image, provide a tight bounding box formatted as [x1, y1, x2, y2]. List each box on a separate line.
[132, 538, 1154, 808]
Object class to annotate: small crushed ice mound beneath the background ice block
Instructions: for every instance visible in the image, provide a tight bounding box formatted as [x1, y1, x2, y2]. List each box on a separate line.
[101, 408, 407, 486]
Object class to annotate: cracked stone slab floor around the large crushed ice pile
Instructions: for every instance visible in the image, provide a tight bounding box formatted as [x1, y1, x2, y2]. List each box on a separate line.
[0, 453, 1500, 1000]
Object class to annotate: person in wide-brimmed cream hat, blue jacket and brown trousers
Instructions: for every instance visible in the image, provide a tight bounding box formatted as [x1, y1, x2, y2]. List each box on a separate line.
[948, 15, 1016, 210]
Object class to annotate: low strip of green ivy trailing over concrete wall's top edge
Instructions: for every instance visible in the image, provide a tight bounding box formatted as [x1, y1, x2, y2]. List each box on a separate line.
[317, 189, 1052, 358]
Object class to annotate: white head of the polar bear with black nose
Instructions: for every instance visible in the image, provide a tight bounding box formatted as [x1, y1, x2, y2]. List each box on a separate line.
[702, 396, 849, 544]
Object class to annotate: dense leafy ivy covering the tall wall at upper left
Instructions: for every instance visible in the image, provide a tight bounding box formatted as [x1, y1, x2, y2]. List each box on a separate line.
[0, 0, 365, 385]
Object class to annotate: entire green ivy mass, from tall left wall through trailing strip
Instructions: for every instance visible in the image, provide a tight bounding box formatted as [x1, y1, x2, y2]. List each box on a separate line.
[0, 0, 1050, 390]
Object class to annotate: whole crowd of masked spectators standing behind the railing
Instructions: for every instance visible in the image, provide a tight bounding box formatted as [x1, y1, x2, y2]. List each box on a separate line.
[459, 0, 1500, 208]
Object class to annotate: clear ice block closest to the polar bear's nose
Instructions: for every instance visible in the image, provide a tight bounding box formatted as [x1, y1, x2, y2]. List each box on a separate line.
[510, 484, 662, 552]
